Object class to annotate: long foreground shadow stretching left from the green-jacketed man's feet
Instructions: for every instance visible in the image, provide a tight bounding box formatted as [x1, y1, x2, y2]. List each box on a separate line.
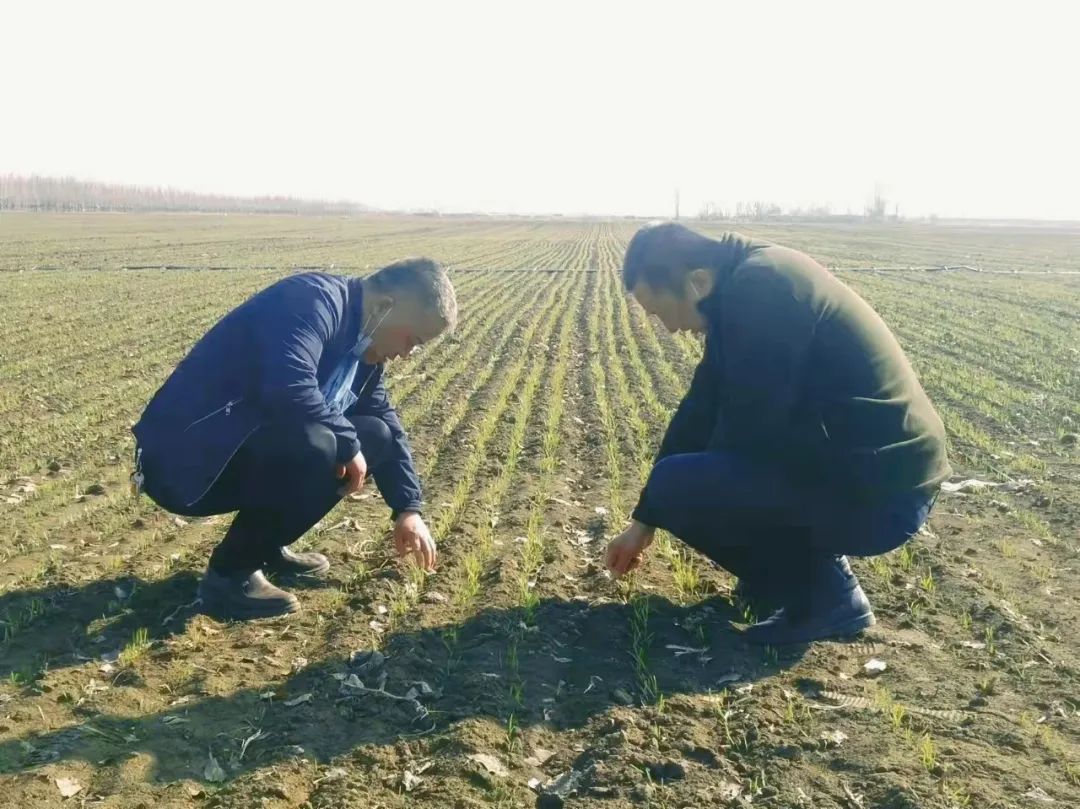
[0, 580, 800, 781]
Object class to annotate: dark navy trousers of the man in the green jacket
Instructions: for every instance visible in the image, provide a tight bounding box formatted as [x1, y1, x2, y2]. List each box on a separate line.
[634, 453, 934, 596]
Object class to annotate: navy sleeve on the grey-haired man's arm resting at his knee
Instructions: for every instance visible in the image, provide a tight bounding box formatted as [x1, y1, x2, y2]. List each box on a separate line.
[253, 280, 360, 463]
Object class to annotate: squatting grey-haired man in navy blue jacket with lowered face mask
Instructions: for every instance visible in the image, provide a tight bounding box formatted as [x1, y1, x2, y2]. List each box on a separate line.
[133, 258, 457, 619]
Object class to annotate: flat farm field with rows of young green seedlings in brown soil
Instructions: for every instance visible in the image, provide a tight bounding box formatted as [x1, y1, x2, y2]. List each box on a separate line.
[0, 214, 1080, 809]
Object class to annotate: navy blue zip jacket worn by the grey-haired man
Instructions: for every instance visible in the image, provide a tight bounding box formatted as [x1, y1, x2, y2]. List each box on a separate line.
[132, 272, 422, 513]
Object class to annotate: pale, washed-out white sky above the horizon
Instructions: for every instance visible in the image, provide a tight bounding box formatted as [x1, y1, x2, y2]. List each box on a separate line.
[0, 0, 1080, 219]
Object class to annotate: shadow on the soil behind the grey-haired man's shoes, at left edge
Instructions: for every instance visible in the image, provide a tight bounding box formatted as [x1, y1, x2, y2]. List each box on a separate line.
[0, 571, 199, 686]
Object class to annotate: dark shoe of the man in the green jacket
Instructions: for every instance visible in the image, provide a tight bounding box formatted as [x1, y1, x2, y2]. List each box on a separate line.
[743, 556, 876, 646]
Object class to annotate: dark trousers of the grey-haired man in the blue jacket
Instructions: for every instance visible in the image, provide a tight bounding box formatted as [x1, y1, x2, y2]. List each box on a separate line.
[177, 416, 391, 571]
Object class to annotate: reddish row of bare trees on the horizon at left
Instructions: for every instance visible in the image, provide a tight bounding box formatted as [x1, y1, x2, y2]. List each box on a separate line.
[0, 174, 370, 214]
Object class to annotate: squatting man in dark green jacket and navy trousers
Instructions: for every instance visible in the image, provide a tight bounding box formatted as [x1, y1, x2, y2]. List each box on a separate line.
[607, 224, 951, 644]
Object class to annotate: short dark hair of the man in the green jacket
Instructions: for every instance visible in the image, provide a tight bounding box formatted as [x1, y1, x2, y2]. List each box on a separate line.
[622, 223, 720, 295]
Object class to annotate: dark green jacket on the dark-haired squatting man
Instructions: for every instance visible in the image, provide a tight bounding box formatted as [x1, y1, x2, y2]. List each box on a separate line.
[635, 233, 951, 502]
